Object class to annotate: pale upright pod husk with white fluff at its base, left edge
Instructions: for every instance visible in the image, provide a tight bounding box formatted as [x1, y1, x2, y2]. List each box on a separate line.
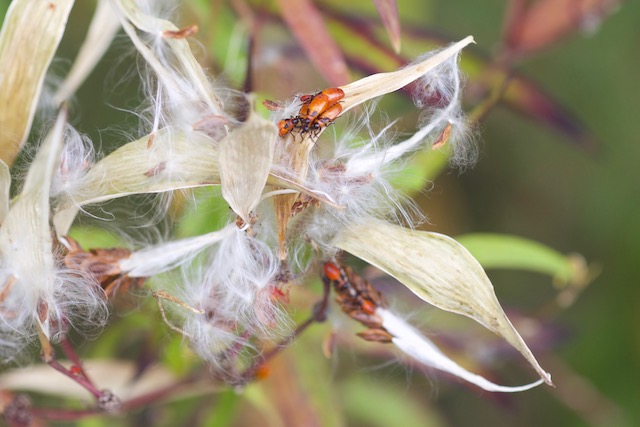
[0, 111, 106, 360]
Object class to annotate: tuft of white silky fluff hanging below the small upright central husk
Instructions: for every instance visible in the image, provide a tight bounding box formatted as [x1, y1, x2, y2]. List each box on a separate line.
[175, 228, 286, 365]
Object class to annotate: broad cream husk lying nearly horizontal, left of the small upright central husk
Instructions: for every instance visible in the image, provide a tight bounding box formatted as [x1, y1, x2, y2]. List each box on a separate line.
[53, 128, 220, 236]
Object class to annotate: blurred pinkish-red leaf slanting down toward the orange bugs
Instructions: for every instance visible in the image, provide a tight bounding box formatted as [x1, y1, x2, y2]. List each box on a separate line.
[278, 0, 351, 86]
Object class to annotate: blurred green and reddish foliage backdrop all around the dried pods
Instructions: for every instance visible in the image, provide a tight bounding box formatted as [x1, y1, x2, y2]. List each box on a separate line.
[0, 0, 640, 427]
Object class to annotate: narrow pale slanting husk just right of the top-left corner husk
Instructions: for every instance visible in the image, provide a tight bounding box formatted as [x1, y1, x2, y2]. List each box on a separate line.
[54, 0, 120, 104]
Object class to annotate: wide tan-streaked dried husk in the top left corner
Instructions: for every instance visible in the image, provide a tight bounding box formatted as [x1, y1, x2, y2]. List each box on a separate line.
[0, 0, 74, 166]
